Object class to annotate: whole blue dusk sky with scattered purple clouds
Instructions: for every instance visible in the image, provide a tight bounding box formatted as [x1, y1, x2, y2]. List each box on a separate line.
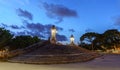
[0, 0, 120, 43]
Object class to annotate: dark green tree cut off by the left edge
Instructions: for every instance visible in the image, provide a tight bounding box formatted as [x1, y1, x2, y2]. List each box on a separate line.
[0, 28, 13, 49]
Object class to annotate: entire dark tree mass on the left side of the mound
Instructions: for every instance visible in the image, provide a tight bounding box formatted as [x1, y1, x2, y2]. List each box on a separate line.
[0, 28, 40, 50]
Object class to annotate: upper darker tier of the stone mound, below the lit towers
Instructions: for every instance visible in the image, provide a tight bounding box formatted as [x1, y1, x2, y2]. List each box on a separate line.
[23, 44, 91, 55]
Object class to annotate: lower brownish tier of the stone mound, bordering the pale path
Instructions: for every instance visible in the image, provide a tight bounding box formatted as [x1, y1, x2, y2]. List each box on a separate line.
[9, 53, 95, 64]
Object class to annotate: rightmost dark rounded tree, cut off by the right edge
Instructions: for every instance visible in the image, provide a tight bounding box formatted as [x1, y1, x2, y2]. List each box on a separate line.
[103, 29, 120, 49]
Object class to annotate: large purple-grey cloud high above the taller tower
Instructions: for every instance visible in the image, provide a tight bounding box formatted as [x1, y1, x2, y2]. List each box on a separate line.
[43, 2, 78, 23]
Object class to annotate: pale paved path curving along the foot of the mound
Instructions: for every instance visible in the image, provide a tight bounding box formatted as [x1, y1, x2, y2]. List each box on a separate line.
[0, 55, 120, 70]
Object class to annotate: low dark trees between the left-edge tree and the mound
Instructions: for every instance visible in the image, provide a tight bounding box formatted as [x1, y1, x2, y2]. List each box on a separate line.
[10, 35, 40, 50]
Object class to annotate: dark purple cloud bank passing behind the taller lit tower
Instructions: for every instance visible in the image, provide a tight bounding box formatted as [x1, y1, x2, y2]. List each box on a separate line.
[25, 22, 67, 41]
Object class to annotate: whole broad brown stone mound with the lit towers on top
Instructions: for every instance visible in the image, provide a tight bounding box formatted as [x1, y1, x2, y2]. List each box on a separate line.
[8, 42, 97, 64]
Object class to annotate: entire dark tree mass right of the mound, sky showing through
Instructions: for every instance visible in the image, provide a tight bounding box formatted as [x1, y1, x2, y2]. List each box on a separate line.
[80, 29, 120, 50]
